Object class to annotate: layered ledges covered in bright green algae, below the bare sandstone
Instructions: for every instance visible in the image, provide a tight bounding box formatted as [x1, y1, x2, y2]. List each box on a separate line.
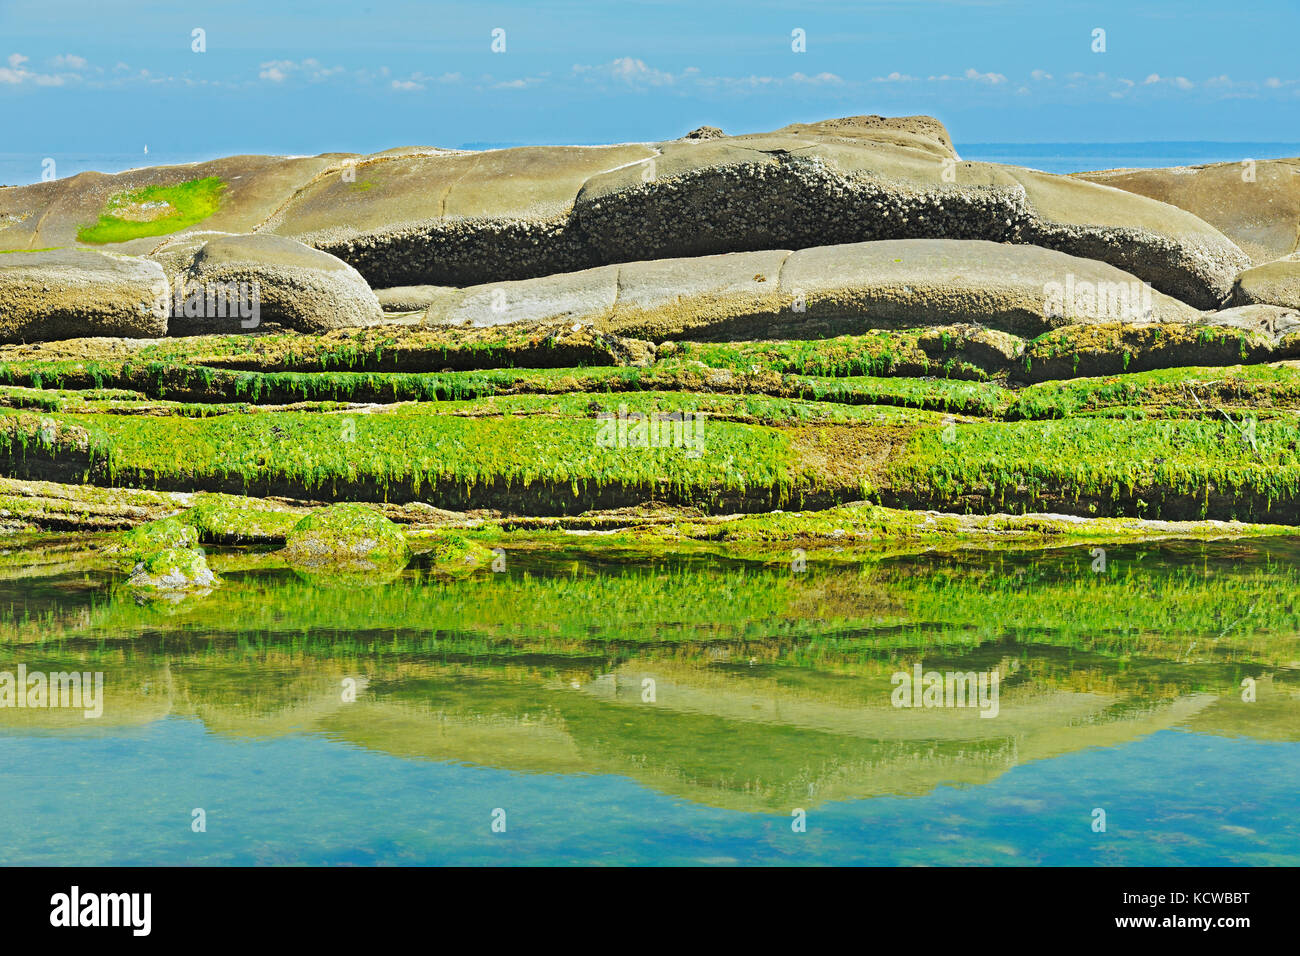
[0, 325, 1300, 524]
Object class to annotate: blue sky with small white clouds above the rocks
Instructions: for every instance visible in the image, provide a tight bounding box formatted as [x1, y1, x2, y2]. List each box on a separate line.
[0, 0, 1300, 156]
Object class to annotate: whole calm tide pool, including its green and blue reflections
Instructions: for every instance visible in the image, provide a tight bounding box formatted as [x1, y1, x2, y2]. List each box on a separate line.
[0, 538, 1300, 865]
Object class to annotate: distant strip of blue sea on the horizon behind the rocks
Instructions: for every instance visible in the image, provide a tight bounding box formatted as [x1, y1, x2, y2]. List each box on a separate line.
[0, 142, 1300, 186]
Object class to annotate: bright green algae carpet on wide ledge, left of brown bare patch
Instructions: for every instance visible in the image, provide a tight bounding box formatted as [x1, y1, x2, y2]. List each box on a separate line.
[35, 406, 794, 509]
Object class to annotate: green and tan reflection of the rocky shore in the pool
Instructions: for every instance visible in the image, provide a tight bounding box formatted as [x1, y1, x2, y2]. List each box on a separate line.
[0, 545, 1300, 812]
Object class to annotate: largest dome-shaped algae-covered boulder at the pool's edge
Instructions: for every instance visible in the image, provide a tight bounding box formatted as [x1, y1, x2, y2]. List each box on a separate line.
[278, 502, 411, 570]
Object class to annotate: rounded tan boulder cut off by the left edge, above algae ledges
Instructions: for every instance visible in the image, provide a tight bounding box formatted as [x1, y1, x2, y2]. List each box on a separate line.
[0, 248, 168, 342]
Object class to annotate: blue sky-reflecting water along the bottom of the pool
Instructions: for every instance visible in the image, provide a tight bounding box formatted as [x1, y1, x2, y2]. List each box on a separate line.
[0, 719, 1300, 866]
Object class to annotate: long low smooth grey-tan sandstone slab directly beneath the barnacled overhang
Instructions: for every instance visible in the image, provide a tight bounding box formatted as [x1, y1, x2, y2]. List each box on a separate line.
[425, 239, 1199, 341]
